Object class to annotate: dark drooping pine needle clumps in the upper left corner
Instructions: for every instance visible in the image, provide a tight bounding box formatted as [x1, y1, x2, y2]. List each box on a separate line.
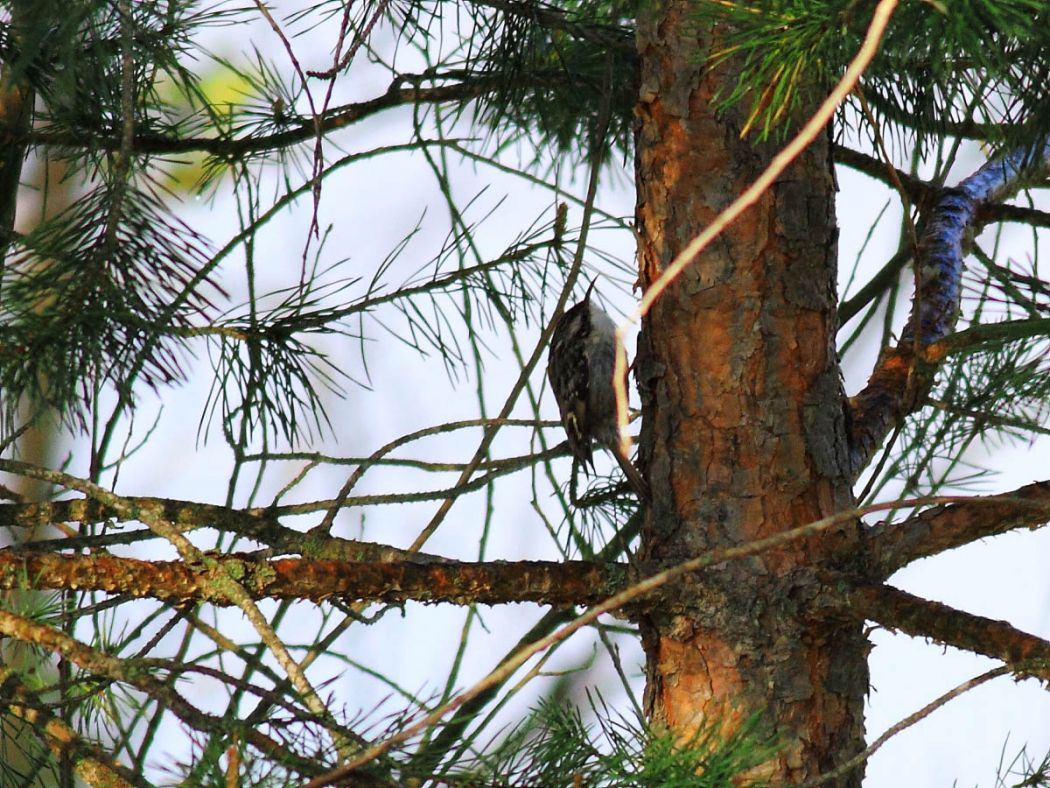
[0, 0, 237, 428]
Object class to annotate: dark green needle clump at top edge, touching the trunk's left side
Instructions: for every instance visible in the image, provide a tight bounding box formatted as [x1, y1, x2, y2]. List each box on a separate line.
[392, 0, 637, 164]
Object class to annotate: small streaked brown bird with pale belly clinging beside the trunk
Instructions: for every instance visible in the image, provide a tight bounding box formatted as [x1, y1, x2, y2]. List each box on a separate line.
[547, 282, 649, 499]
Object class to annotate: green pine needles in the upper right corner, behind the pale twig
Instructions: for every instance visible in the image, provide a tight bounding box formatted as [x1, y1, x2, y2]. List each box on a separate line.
[697, 0, 1050, 148]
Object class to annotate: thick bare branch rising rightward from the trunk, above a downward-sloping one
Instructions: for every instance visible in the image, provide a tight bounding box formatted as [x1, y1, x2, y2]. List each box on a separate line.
[865, 481, 1050, 580]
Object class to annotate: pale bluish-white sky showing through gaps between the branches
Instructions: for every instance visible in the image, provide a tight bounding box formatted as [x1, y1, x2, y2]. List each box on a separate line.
[10, 4, 1050, 788]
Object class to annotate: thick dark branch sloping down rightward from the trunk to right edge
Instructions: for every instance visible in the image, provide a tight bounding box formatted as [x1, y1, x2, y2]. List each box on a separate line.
[849, 585, 1050, 681]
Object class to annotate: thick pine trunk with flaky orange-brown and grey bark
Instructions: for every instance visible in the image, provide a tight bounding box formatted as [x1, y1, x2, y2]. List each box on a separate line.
[635, 6, 867, 784]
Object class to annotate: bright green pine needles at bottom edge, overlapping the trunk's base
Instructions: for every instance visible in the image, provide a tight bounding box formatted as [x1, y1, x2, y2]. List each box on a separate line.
[447, 697, 776, 788]
